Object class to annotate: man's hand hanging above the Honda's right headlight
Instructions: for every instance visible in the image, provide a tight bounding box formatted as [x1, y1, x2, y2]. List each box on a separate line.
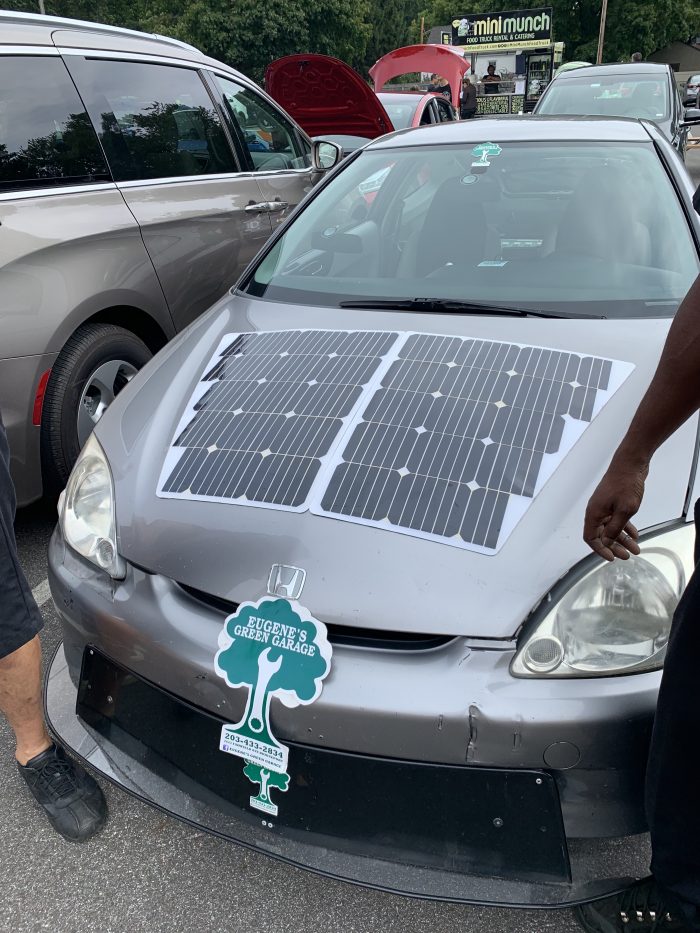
[583, 460, 649, 560]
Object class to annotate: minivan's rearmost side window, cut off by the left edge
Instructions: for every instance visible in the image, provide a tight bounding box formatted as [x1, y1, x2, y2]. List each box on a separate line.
[0, 56, 111, 190]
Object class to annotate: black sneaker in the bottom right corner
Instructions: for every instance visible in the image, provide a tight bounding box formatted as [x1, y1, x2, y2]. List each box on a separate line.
[574, 878, 700, 933]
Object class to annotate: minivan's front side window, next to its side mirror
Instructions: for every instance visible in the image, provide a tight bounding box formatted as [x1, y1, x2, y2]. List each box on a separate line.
[216, 76, 311, 172]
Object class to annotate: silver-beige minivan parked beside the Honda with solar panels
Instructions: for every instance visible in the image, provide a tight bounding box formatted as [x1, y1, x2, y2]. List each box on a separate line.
[0, 12, 334, 504]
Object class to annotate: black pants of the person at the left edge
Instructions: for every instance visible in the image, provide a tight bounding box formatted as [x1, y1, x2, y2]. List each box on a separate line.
[0, 418, 43, 658]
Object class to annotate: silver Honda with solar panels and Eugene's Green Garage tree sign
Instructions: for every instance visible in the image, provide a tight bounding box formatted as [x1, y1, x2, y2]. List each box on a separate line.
[47, 118, 700, 906]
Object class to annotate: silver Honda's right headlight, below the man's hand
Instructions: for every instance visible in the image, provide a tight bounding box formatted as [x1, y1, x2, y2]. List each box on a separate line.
[511, 523, 695, 677]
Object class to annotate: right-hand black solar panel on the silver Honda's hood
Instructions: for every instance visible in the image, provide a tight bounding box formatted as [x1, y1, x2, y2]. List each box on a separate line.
[320, 334, 612, 550]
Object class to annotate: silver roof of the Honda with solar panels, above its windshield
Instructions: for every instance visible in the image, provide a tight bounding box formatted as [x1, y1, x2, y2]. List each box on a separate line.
[366, 116, 650, 149]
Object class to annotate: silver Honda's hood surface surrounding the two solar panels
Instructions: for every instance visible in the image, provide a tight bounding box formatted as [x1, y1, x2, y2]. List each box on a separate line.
[101, 296, 697, 639]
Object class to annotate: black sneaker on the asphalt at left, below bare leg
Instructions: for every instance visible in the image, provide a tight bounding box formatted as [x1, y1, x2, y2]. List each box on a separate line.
[17, 745, 107, 842]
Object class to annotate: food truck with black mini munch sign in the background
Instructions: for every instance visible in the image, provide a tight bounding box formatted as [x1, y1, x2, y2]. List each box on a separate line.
[451, 7, 564, 115]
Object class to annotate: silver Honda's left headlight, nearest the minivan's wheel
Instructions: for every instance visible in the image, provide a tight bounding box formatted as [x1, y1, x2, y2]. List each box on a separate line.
[59, 434, 126, 580]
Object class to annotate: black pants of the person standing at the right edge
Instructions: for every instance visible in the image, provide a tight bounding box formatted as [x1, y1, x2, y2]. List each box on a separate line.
[647, 501, 700, 908]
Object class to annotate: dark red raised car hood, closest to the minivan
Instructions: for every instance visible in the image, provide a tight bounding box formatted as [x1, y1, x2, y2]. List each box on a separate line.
[265, 55, 394, 139]
